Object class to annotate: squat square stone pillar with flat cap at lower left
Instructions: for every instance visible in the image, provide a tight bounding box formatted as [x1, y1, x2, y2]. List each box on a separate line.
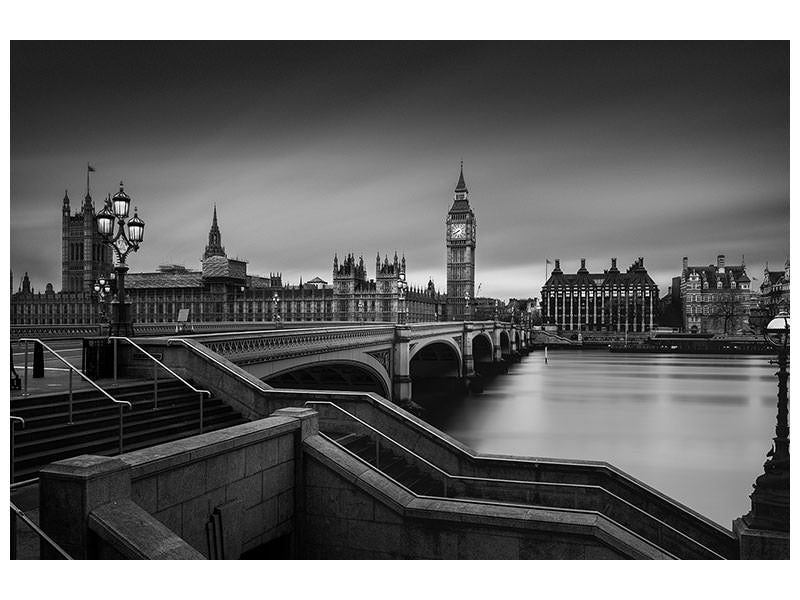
[39, 454, 131, 559]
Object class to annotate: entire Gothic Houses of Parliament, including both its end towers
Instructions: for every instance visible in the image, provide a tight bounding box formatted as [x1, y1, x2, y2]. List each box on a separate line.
[11, 163, 477, 326]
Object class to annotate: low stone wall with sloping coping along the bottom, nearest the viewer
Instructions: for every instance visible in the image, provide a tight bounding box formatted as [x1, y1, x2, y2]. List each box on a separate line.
[302, 436, 667, 559]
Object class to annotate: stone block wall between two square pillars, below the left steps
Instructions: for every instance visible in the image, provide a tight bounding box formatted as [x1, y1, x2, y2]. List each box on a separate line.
[122, 417, 306, 557]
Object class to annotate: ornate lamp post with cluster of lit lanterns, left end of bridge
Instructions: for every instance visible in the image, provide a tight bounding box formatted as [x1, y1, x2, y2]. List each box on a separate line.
[95, 181, 144, 336]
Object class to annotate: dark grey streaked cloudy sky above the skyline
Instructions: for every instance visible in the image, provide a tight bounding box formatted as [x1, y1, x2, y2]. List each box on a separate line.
[10, 41, 789, 298]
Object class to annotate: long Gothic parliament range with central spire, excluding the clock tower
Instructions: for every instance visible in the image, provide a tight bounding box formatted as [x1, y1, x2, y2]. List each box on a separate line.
[11, 200, 446, 325]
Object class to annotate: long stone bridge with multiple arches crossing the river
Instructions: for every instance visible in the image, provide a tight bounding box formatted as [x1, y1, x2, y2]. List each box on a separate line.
[104, 321, 533, 404]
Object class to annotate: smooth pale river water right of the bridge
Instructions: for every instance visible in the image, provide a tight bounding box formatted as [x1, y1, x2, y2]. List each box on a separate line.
[418, 350, 777, 529]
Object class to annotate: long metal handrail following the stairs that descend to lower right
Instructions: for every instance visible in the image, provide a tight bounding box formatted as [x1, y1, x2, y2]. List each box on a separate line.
[305, 400, 725, 559]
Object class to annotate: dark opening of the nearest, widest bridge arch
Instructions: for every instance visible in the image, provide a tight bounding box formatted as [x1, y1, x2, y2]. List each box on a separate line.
[261, 359, 392, 399]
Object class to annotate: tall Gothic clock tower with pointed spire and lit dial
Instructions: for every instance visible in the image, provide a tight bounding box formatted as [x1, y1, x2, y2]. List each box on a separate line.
[446, 161, 475, 321]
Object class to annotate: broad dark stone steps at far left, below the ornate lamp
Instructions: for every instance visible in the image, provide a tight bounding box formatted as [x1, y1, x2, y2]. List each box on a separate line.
[10, 381, 246, 481]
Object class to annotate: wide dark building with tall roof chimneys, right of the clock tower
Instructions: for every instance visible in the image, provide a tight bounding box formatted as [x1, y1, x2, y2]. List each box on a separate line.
[541, 257, 658, 332]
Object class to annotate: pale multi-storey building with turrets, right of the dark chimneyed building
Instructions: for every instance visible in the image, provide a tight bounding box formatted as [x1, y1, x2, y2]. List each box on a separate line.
[680, 254, 755, 335]
